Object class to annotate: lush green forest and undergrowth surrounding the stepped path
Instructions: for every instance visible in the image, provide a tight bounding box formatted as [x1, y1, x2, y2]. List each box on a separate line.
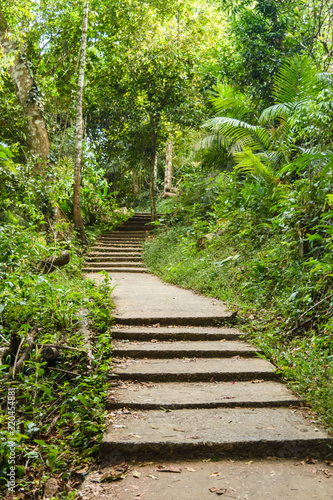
[0, 0, 333, 500]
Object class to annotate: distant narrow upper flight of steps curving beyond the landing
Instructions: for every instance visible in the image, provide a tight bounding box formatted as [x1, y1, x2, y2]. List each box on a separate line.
[83, 212, 153, 273]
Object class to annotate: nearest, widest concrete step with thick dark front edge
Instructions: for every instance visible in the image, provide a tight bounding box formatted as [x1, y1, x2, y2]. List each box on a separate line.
[100, 408, 332, 460]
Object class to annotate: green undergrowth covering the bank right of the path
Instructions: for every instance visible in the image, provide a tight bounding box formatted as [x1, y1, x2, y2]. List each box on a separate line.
[144, 167, 333, 429]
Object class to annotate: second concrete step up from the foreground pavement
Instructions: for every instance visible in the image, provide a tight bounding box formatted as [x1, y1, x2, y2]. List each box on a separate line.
[107, 381, 301, 410]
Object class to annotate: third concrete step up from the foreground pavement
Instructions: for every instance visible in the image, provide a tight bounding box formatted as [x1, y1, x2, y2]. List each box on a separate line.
[113, 356, 276, 382]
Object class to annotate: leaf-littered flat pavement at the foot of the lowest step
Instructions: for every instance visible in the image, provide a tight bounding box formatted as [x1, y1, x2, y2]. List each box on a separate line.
[80, 454, 333, 500]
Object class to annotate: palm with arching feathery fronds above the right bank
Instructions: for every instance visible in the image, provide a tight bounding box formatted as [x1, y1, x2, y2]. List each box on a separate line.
[200, 55, 331, 192]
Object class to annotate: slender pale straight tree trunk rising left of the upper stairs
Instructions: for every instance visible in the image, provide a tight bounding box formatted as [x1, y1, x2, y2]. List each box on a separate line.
[73, 0, 89, 243]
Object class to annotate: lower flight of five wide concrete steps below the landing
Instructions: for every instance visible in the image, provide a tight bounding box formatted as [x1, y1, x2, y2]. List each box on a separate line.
[101, 321, 332, 461]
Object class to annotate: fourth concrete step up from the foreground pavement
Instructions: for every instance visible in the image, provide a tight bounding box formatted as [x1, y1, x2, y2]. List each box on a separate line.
[112, 340, 258, 358]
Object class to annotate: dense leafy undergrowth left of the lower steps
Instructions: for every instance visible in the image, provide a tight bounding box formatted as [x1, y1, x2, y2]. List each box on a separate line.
[0, 224, 113, 499]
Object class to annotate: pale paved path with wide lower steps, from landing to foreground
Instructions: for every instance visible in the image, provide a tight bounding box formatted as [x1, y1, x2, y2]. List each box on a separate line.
[81, 217, 333, 500]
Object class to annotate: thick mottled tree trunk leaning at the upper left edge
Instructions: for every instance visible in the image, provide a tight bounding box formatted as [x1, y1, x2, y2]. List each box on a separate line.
[0, 9, 50, 173]
